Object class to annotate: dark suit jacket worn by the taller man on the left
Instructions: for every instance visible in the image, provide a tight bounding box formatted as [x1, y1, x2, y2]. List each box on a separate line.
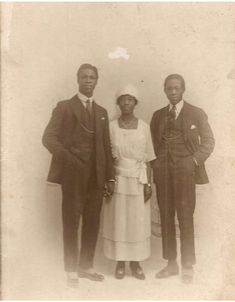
[42, 95, 114, 187]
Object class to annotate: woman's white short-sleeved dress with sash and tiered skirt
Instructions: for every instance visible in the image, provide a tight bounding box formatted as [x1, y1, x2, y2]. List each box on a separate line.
[103, 119, 155, 261]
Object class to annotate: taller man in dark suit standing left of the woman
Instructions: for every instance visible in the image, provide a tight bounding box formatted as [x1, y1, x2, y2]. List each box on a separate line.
[42, 64, 114, 287]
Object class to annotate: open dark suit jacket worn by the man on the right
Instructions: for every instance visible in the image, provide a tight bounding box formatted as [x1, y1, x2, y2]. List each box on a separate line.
[150, 102, 215, 184]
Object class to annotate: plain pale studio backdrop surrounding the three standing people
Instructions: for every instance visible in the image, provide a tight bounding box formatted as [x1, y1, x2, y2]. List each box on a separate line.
[1, 3, 235, 299]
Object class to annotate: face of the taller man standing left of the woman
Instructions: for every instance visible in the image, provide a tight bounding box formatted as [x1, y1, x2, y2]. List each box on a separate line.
[77, 68, 98, 97]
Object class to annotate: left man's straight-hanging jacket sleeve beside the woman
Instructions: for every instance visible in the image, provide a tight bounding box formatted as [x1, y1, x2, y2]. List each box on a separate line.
[104, 111, 115, 181]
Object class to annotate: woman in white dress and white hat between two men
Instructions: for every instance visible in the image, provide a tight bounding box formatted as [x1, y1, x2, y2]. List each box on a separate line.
[103, 85, 155, 280]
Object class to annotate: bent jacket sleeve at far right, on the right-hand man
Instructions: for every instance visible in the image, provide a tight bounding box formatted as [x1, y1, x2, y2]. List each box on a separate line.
[193, 110, 215, 165]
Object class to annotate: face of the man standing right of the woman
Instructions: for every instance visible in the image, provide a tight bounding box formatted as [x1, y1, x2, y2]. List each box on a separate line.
[164, 79, 184, 105]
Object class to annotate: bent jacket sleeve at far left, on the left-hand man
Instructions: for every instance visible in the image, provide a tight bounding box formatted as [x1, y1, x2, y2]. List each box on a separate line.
[42, 102, 69, 159]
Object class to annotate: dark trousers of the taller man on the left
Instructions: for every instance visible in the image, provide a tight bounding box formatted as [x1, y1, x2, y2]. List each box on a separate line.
[62, 159, 103, 272]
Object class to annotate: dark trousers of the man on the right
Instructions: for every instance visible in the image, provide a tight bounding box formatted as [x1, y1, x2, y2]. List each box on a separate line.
[154, 156, 196, 266]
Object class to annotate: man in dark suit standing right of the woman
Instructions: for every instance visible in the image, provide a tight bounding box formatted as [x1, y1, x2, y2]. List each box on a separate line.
[150, 74, 215, 283]
